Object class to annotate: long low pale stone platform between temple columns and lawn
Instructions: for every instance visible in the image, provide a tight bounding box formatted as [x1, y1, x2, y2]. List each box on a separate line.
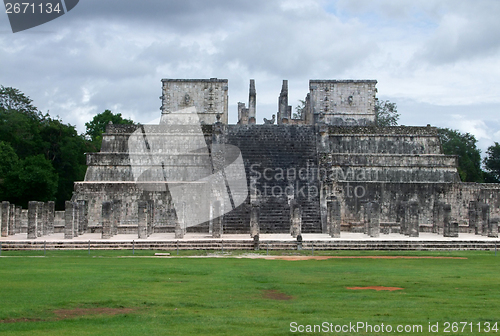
[0, 232, 500, 251]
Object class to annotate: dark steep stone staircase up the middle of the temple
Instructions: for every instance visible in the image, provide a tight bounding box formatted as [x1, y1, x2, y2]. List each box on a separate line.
[224, 125, 321, 233]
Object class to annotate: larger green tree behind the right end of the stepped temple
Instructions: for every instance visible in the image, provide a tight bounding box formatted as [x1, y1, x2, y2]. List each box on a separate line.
[438, 128, 484, 182]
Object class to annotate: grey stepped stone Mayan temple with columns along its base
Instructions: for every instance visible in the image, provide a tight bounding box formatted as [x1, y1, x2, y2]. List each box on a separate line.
[2, 78, 500, 244]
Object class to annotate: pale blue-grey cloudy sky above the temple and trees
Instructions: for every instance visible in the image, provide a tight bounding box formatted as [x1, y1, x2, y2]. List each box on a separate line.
[0, 0, 500, 153]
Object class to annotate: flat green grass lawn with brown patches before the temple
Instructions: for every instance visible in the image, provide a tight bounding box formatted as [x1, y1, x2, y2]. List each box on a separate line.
[0, 251, 500, 336]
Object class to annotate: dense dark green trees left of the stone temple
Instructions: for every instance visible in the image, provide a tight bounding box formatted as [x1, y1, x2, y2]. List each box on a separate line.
[0, 86, 135, 209]
